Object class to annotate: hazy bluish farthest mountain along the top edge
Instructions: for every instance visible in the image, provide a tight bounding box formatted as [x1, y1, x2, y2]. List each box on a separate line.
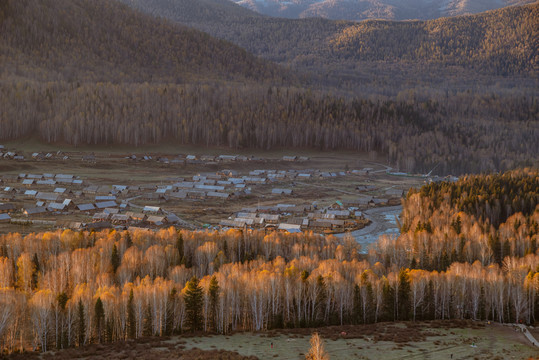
[232, 0, 536, 21]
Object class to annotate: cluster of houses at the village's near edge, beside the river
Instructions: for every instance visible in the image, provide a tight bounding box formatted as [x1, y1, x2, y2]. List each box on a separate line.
[219, 199, 372, 233]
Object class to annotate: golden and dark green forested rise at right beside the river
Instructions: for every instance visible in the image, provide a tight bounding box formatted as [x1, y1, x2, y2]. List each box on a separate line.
[371, 170, 539, 271]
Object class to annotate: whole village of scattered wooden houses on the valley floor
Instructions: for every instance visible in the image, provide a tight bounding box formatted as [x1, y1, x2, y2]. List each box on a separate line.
[0, 146, 418, 234]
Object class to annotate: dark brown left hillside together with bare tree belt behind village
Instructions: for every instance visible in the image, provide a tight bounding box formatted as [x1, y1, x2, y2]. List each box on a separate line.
[0, 0, 539, 174]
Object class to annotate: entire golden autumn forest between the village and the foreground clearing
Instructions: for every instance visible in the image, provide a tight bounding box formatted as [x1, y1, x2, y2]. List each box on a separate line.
[0, 170, 539, 352]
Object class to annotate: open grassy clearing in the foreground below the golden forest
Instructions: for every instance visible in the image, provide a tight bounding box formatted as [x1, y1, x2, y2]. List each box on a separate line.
[7, 321, 539, 360]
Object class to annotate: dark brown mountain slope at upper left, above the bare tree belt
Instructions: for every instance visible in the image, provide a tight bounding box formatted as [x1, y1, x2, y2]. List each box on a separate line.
[0, 0, 279, 82]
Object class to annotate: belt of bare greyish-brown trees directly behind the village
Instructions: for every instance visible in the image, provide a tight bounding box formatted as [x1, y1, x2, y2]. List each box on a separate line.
[0, 81, 539, 174]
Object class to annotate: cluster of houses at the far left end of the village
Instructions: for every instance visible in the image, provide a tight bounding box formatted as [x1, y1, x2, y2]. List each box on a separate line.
[0, 174, 187, 228]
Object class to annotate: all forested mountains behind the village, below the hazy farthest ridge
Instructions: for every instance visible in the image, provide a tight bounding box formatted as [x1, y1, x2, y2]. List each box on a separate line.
[0, 0, 539, 173]
